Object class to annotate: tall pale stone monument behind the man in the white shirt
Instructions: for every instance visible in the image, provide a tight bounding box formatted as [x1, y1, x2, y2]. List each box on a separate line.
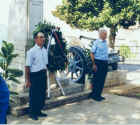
[8, 0, 44, 83]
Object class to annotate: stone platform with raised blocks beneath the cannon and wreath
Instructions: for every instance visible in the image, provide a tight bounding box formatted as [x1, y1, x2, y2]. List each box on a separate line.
[11, 84, 87, 116]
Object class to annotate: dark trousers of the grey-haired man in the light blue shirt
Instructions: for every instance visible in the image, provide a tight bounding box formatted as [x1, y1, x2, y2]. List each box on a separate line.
[91, 60, 108, 97]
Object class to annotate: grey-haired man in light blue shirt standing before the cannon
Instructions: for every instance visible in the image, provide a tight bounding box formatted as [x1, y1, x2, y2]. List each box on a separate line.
[90, 29, 108, 101]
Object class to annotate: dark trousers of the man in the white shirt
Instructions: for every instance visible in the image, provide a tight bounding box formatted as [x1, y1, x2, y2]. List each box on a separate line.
[29, 70, 47, 115]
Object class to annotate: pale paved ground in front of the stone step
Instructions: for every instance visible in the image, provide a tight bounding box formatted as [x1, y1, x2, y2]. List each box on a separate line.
[8, 94, 140, 124]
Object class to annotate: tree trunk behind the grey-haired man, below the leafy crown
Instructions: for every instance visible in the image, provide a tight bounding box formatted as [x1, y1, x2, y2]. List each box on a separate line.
[109, 26, 117, 49]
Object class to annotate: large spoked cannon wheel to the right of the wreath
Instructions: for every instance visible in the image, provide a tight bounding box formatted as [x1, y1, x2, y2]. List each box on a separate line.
[57, 46, 86, 83]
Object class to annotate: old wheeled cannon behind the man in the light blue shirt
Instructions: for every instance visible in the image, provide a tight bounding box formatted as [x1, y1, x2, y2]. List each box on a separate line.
[60, 36, 124, 83]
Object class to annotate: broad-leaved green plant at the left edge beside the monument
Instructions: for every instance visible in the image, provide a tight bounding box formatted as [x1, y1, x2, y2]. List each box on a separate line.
[0, 41, 23, 83]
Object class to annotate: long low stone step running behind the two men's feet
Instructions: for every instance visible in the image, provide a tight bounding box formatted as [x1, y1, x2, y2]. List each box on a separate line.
[11, 91, 91, 117]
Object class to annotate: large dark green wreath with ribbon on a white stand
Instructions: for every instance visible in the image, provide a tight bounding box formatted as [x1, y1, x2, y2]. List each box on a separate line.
[33, 22, 67, 72]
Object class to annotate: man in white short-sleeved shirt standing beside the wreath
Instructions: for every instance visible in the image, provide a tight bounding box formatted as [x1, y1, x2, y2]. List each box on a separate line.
[25, 32, 48, 120]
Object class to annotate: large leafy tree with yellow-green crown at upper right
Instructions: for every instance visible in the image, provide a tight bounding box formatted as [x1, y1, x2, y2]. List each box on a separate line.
[53, 0, 140, 48]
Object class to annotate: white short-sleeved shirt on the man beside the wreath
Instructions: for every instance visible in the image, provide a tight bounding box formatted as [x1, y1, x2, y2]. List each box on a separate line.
[26, 44, 48, 72]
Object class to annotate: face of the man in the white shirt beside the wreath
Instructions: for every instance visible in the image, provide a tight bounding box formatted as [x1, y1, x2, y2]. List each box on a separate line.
[35, 32, 45, 47]
